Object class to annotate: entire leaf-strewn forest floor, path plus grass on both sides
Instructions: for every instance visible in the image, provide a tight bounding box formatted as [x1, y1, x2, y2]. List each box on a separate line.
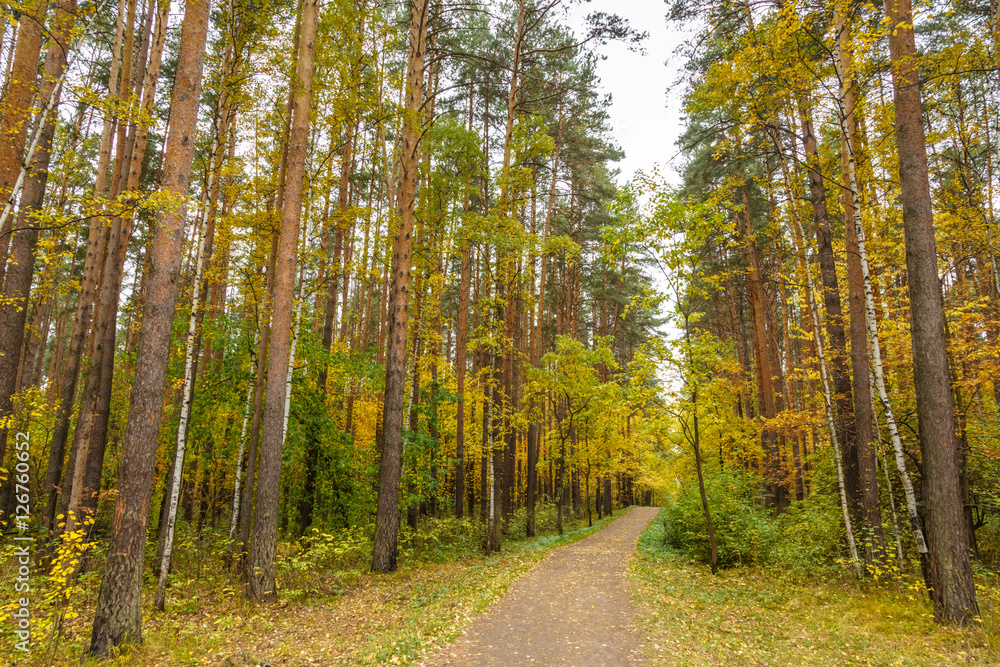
[9, 508, 1000, 667]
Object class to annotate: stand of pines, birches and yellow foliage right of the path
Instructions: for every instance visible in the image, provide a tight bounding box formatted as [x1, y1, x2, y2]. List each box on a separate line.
[640, 0, 1000, 624]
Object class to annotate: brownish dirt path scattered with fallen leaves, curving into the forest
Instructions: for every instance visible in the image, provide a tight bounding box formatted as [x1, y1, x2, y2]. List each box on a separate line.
[426, 507, 658, 667]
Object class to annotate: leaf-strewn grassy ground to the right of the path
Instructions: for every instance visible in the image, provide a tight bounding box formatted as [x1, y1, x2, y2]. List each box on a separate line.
[630, 508, 1000, 666]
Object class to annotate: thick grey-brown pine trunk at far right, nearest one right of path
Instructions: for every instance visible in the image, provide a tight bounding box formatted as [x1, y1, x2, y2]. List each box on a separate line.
[885, 0, 979, 625]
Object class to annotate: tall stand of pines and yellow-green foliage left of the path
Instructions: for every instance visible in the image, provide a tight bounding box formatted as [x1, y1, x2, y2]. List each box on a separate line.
[0, 0, 657, 655]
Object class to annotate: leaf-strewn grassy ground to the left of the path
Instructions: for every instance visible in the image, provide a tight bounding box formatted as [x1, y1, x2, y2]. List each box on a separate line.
[0, 508, 608, 667]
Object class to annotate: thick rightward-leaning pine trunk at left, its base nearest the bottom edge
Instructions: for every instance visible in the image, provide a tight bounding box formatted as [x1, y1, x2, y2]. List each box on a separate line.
[90, 0, 210, 656]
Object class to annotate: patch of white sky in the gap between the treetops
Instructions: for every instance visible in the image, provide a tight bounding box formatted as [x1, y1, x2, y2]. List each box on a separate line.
[571, 0, 685, 188]
